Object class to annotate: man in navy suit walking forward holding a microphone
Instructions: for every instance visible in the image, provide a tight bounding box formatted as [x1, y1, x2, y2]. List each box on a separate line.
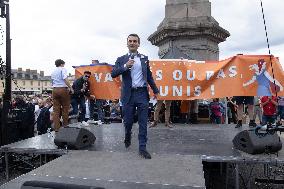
[111, 34, 159, 159]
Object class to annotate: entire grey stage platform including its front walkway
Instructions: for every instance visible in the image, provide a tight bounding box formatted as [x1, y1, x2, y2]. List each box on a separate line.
[0, 123, 284, 189]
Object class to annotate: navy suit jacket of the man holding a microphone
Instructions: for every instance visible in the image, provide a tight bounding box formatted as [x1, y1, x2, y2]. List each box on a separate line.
[111, 54, 159, 105]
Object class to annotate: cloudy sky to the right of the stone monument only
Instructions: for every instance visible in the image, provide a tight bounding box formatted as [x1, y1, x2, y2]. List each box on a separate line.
[212, 0, 284, 65]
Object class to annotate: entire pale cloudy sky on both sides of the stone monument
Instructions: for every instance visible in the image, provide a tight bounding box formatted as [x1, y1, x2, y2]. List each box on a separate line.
[0, 0, 284, 75]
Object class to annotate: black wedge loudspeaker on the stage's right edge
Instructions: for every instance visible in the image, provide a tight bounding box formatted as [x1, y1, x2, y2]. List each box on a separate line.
[233, 130, 282, 154]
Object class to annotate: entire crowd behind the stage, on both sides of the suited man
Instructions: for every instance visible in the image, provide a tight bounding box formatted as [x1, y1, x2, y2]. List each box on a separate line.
[3, 92, 284, 141]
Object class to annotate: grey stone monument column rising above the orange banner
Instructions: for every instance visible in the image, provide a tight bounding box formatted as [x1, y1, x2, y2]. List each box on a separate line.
[148, 0, 230, 60]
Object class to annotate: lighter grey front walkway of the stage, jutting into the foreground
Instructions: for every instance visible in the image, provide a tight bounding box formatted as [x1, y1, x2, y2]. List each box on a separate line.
[0, 151, 204, 189]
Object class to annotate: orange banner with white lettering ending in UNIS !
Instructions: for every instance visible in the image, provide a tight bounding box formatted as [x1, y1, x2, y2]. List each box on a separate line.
[75, 55, 284, 100]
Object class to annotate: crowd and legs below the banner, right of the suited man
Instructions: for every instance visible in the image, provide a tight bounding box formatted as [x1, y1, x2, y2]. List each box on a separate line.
[150, 96, 284, 128]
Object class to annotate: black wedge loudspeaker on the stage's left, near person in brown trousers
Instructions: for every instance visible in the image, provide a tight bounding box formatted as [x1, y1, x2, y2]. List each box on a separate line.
[54, 127, 96, 150]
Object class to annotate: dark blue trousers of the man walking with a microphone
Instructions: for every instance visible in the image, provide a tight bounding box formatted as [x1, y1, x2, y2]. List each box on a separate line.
[122, 87, 149, 150]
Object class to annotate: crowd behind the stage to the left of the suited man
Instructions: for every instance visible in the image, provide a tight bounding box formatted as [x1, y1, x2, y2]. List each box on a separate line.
[5, 94, 122, 135]
